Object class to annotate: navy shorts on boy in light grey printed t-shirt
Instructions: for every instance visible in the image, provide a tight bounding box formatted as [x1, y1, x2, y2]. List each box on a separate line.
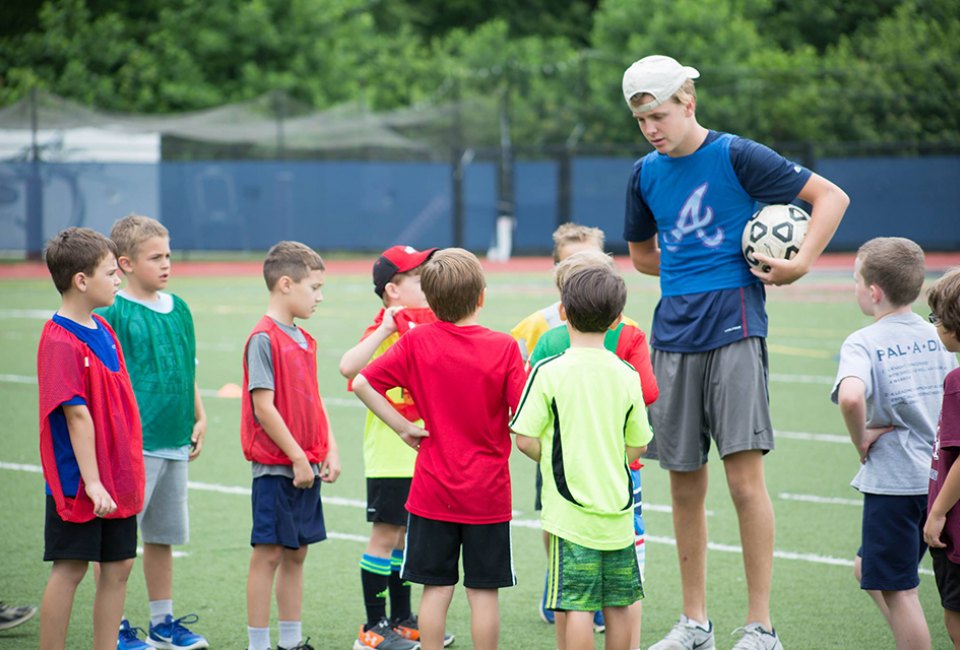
[857, 494, 927, 591]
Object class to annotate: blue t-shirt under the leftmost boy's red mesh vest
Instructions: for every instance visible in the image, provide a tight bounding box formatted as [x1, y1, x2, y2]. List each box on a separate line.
[46, 314, 120, 497]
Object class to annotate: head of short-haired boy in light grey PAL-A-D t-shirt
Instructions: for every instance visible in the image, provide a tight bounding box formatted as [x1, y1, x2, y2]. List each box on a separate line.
[857, 237, 924, 307]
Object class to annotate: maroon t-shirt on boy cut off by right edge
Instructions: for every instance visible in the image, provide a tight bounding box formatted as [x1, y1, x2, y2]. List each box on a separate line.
[927, 368, 960, 564]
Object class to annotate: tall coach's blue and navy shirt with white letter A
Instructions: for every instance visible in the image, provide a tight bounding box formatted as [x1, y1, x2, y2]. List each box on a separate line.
[624, 131, 811, 352]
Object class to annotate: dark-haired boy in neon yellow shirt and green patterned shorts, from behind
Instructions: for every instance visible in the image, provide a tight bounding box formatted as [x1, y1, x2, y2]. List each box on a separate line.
[510, 266, 652, 650]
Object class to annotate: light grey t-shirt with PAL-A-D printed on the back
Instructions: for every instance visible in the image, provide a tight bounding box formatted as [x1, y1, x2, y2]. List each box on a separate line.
[831, 312, 957, 495]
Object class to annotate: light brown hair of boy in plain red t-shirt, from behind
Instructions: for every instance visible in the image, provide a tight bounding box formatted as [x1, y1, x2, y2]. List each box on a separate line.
[420, 248, 487, 323]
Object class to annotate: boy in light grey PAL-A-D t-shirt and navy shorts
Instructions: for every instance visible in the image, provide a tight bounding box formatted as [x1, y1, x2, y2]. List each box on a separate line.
[831, 237, 957, 648]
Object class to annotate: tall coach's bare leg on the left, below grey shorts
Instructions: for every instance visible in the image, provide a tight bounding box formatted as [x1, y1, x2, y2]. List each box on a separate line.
[670, 465, 708, 624]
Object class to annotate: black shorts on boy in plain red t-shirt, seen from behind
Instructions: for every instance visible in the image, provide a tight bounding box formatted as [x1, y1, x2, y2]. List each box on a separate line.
[402, 514, 517, 589]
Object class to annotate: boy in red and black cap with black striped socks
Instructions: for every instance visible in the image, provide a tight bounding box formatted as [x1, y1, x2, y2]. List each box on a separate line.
[340, 246, 442, 650]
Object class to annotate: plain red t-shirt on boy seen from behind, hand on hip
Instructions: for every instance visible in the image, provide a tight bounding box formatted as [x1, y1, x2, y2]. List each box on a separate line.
[360, 322, 525, 524]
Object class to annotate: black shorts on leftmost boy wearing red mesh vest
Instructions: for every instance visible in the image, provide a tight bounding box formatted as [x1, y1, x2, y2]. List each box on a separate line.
[43, 494, 137, 562]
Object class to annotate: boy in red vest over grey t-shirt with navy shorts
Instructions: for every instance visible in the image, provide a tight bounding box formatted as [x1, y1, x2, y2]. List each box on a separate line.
[240, 241, 340, 650]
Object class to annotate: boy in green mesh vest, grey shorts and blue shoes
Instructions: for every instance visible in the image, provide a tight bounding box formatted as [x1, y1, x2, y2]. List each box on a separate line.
[99, 214, 209, 650]
